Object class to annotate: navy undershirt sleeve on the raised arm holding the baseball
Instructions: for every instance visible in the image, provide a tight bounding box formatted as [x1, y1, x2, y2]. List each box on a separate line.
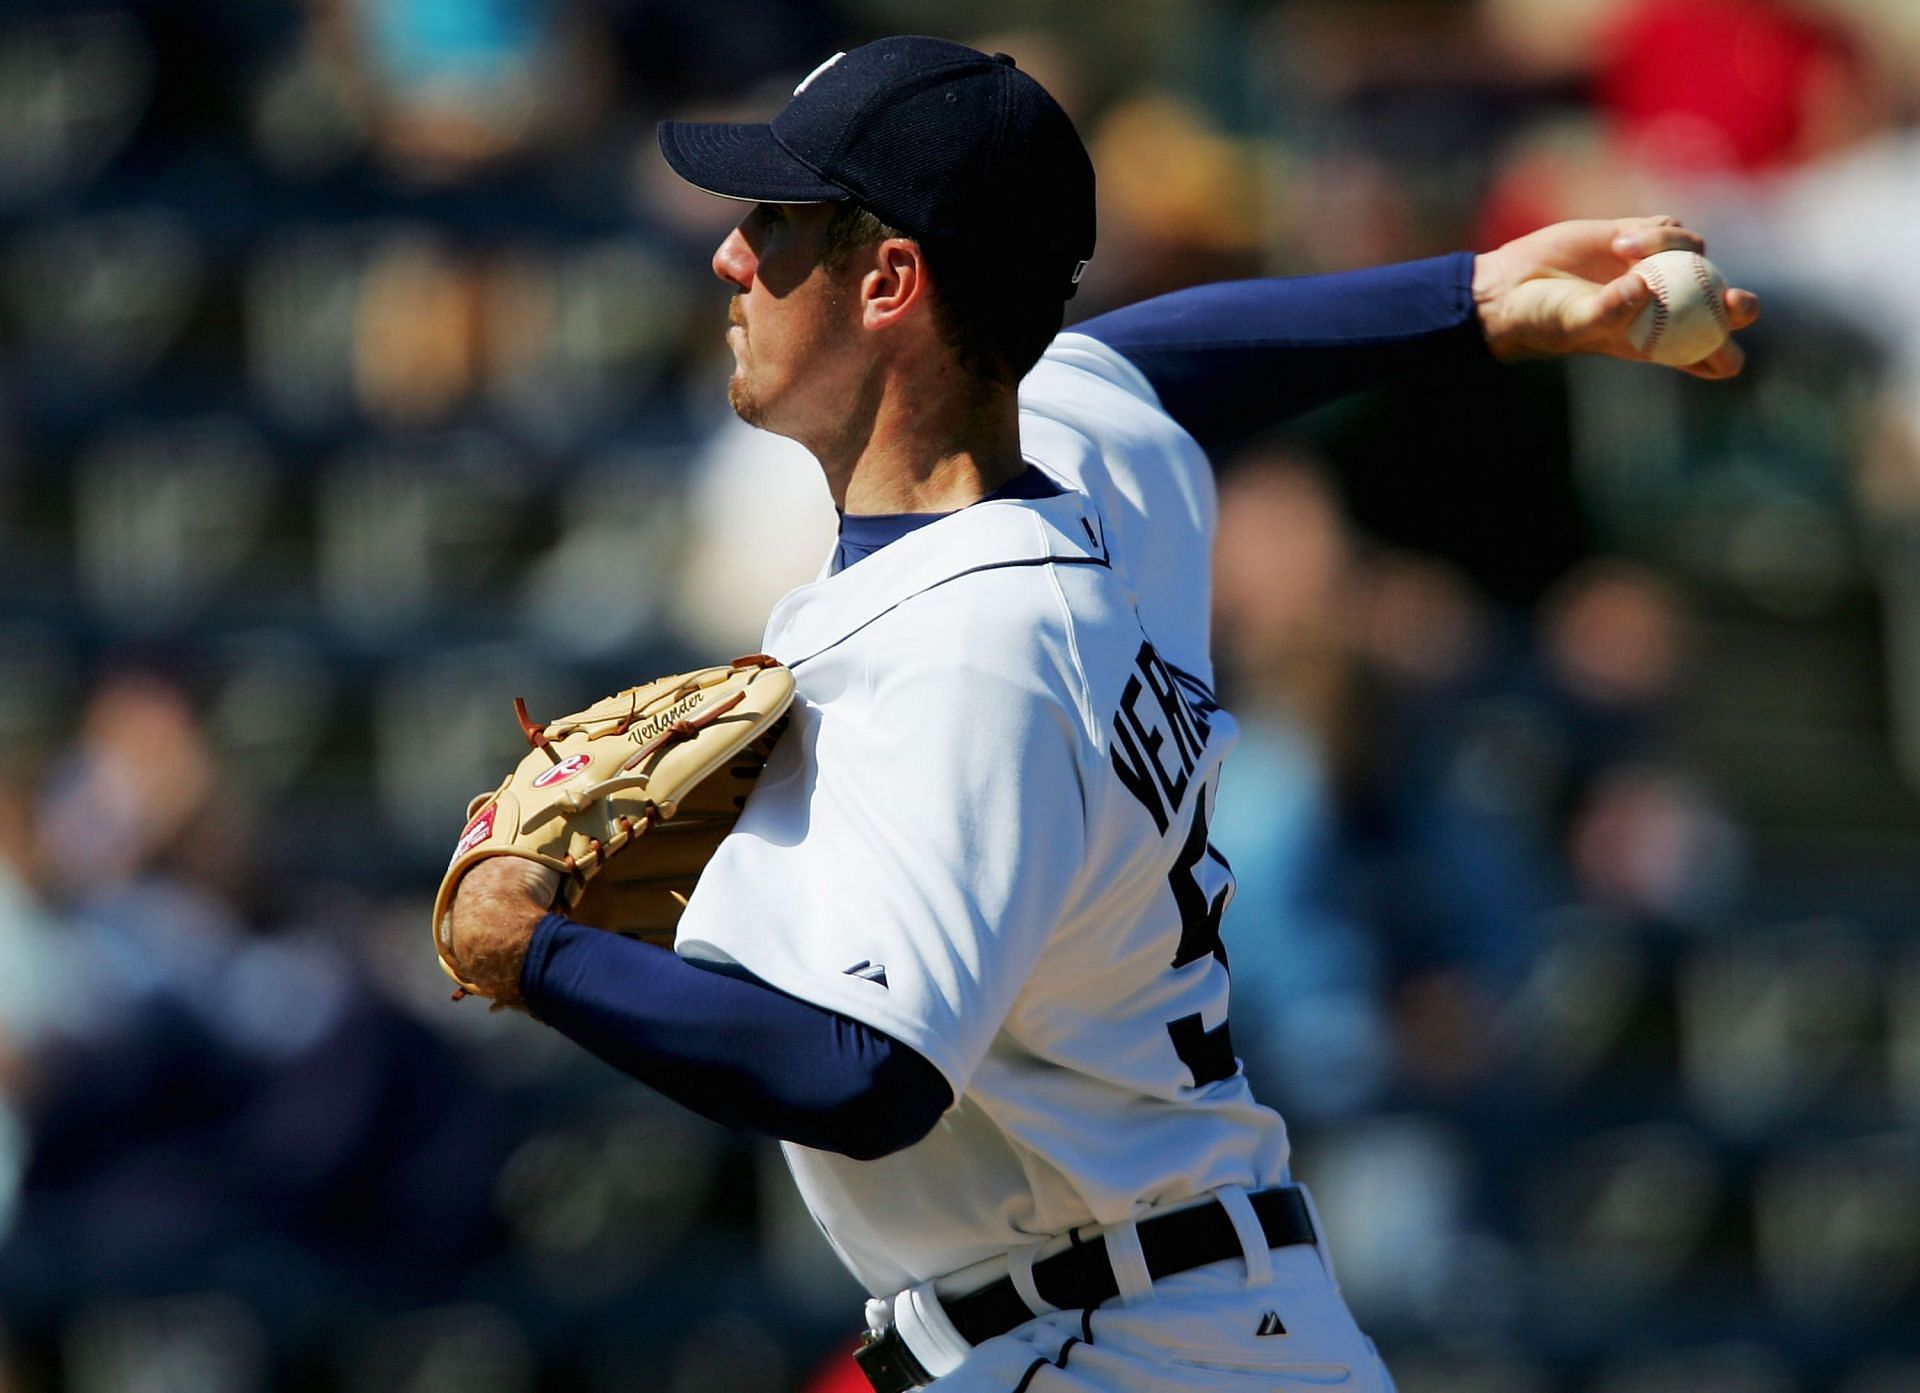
[1073, 251, 1486, 449]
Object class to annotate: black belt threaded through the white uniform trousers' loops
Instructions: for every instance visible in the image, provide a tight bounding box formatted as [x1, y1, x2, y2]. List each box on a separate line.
[854, 1186, 1313, 1393]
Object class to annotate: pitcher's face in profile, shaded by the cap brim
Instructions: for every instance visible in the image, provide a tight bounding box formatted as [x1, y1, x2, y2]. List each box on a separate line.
[712, 203, 858, 437]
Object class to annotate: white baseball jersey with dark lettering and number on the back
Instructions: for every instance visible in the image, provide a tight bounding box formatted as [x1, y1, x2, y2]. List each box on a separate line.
[678, 334, 1286, 1295]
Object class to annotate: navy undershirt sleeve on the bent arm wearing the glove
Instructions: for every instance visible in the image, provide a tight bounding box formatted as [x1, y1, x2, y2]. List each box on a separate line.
[520, 913, 952, 1161]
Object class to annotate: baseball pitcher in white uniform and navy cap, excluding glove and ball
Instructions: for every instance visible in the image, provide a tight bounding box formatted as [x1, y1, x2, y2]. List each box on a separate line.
[453, 38, 1757, 1393]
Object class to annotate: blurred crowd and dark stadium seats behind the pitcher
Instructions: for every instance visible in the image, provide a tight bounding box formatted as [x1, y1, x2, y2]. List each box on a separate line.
[0, 0, 1920, 1393]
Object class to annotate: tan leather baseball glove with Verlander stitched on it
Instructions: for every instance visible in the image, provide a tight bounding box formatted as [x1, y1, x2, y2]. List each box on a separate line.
[434, 654, 793, 1000]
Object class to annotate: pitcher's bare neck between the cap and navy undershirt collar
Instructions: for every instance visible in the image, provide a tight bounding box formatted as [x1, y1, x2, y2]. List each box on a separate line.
[820, 384, 1025, 516]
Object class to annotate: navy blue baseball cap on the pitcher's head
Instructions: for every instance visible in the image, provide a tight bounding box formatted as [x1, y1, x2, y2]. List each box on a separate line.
[660, 36, 1094, 299]
